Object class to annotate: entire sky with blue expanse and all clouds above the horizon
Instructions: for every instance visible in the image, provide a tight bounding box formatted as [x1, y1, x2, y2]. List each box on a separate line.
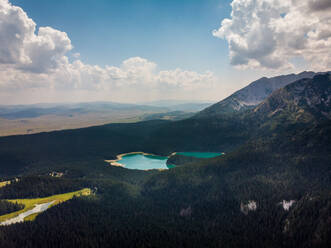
[0, 0, 331, 104]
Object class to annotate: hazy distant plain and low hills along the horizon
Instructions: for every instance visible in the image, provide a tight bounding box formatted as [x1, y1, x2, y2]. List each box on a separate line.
[0, 101, 210, 136]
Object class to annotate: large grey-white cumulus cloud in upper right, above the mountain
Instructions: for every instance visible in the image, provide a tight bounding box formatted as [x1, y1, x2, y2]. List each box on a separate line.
[213, 0, 331, 70]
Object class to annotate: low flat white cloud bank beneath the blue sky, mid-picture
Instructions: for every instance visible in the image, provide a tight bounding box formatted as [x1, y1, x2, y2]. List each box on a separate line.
[49, 57, 216, 93]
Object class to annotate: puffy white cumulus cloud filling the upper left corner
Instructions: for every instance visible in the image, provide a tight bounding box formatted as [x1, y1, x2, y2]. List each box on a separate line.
[0, 0, 72, 73]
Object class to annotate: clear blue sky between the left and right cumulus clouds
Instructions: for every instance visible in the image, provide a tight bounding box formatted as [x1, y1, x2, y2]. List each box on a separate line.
[11, 0, 231, 73]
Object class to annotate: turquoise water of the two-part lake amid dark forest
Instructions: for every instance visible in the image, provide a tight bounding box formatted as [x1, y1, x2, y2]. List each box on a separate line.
[118, 152, 222, 170]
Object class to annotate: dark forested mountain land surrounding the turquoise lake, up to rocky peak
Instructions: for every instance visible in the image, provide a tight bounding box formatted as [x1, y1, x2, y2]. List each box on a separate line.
[0, 72, 331, 248]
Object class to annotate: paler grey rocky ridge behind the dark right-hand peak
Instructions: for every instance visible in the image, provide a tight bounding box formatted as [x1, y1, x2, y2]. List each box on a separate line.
[196, 71, 318, 118]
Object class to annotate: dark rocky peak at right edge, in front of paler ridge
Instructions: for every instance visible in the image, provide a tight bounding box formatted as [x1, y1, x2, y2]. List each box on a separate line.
[254, 73, 331, 122]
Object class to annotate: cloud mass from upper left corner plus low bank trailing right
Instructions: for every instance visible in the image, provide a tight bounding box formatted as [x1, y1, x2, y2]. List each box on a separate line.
[0, 0, 216, 101]
